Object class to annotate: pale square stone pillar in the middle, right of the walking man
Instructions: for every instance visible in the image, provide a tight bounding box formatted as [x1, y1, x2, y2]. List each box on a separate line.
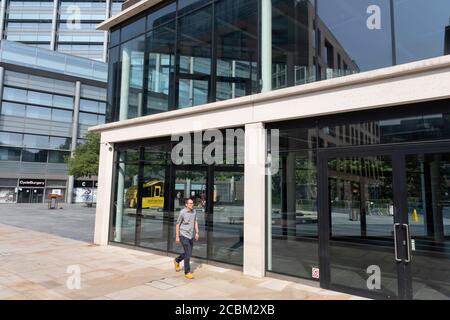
[244, 123, 266, 277]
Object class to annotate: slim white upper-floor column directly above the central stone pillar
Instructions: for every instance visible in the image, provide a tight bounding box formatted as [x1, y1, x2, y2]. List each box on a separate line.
[261, 0, 272, 92]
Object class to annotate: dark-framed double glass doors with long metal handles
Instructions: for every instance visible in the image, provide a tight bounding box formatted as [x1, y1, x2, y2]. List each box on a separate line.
[319, 143, 450, 299]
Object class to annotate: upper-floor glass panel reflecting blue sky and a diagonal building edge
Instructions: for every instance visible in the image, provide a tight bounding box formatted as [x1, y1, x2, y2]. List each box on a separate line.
[318, 0, 393, 74]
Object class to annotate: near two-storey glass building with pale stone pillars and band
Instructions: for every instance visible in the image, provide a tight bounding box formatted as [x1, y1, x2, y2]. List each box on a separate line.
[91, 0, 450, 299]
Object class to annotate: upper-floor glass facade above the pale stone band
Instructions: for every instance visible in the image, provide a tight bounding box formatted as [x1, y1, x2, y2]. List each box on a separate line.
[107, 0, 450, 122]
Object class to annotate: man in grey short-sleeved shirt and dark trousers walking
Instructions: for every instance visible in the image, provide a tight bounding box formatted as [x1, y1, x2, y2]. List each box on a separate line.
[174, 198, 198, 279]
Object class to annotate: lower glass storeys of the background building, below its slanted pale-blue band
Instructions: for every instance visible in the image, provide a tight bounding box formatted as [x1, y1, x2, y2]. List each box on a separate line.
[0, 66, 106, 203]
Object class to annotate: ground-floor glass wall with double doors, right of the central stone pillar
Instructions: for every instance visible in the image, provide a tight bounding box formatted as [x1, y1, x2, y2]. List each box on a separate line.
[267, 100, 450, 299]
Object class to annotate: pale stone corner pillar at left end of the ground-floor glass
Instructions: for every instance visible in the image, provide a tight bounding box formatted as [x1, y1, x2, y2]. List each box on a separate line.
[94, 140, 114, 246]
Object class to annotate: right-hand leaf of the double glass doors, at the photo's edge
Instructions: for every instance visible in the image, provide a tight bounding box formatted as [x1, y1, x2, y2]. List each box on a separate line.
[405, 153, 450, 299]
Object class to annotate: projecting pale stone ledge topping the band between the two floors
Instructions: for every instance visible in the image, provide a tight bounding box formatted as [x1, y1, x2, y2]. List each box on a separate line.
[89, 55, 450, 132]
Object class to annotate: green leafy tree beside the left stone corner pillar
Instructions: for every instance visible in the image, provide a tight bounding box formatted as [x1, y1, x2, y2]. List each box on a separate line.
[66, 132, 100, 178]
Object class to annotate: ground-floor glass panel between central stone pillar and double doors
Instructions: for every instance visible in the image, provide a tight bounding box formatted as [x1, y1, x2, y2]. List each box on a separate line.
[268, 149, 319, 279]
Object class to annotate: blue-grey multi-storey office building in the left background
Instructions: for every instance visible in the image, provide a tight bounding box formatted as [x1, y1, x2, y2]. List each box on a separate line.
[0, 0, 123, 203]
